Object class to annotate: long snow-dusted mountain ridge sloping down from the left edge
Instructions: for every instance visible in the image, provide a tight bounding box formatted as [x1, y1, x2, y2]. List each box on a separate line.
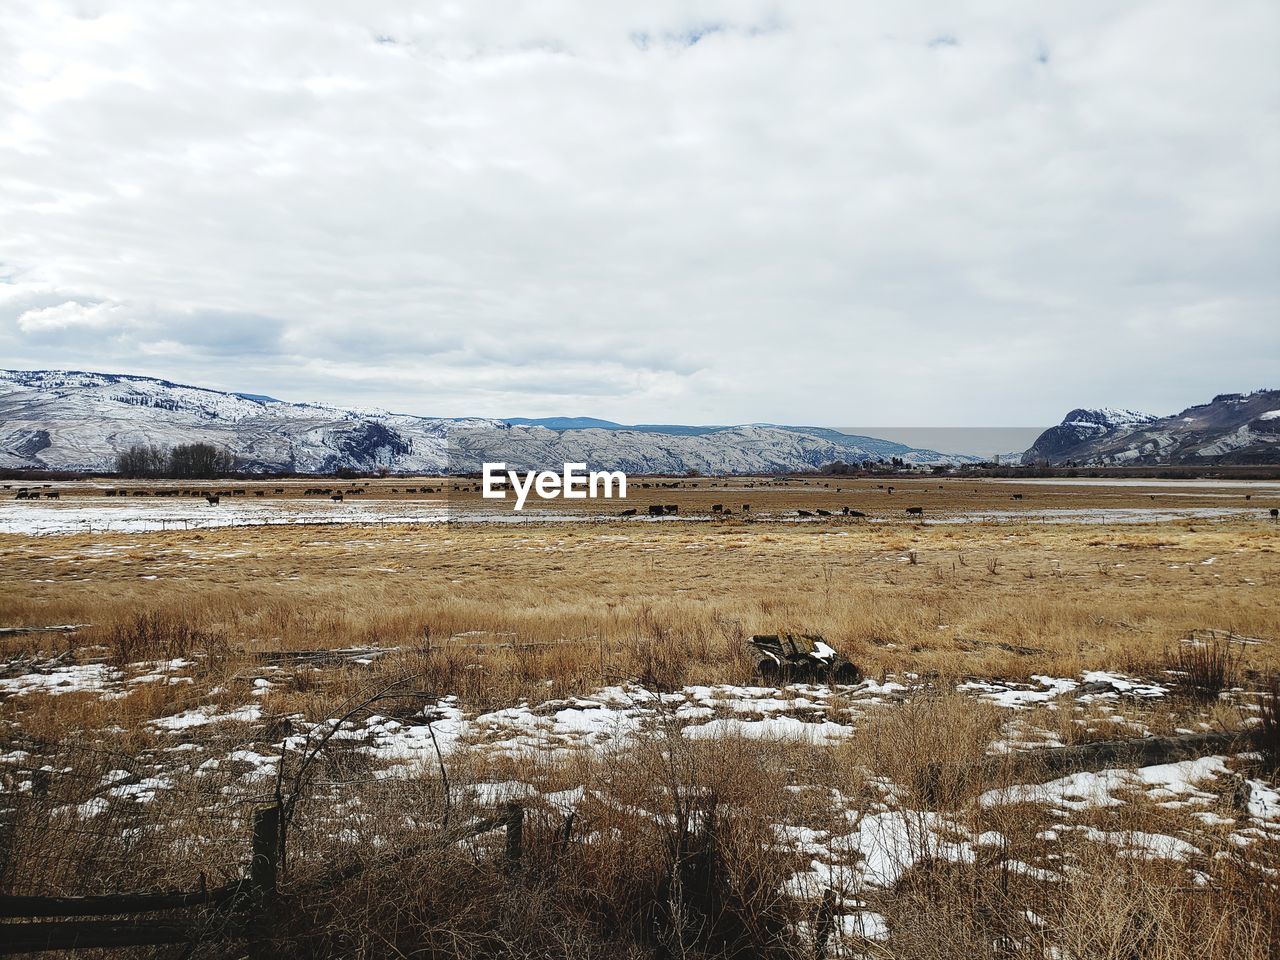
[0, 370, 972, 474]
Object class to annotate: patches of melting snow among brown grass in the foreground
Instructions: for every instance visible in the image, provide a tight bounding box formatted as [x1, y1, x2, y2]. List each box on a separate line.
[0, 650, 1280, 940]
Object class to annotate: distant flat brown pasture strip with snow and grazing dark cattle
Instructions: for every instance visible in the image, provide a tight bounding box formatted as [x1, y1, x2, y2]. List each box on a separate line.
[0, 477, 1280, 534]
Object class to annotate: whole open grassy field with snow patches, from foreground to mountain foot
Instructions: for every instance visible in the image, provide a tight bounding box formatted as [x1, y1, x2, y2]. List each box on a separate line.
[0, 477, 1280, 959]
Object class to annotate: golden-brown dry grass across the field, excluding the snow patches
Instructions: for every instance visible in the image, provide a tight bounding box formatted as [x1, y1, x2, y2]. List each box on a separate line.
[0, 486, 1280, 960]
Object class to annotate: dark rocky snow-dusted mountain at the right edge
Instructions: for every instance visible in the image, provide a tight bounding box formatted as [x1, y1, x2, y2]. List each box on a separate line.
[1023, 390, 1280, 466]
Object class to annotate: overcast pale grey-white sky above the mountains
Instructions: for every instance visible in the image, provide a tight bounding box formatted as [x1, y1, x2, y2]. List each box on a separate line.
[0, 0, 1280, 426]
